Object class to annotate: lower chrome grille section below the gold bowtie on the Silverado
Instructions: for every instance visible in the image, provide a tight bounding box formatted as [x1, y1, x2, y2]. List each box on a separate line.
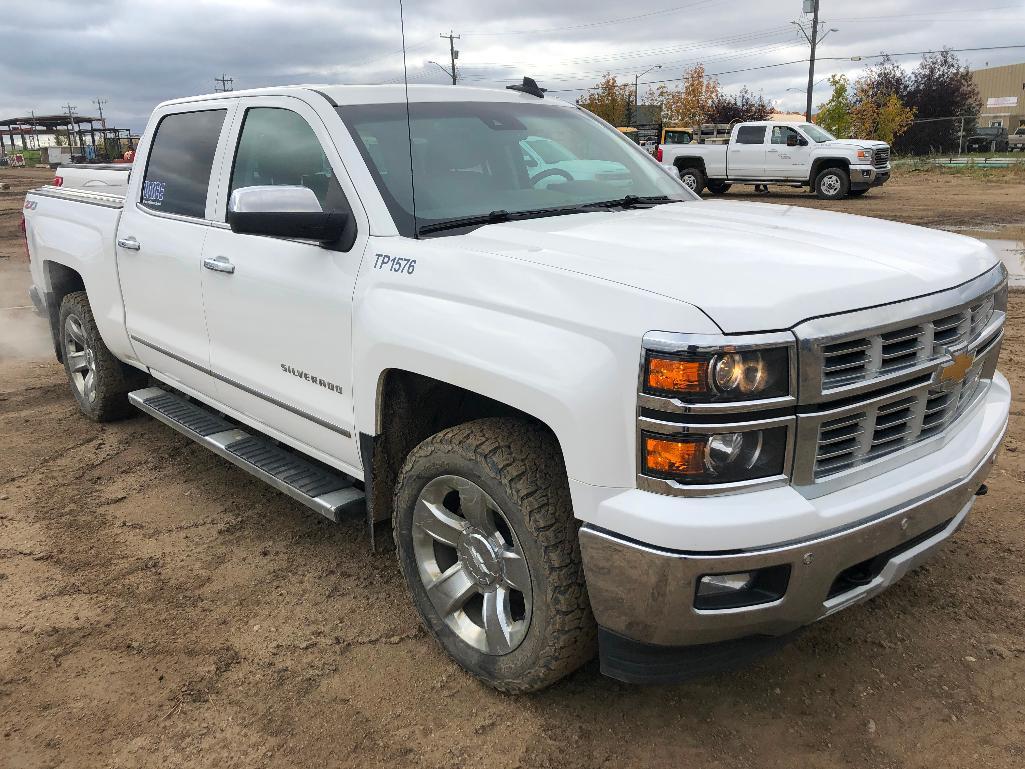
[814, 340, 999, 481]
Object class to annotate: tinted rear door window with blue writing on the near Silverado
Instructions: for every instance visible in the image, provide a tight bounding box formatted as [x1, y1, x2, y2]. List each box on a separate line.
[139, 110, 227, 218]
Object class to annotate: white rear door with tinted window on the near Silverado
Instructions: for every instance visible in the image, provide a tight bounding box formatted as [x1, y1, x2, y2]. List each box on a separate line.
[116, 98, 237, 397]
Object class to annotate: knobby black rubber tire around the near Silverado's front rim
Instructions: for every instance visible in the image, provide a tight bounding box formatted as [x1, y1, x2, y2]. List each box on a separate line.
[393, 418, 597, 692]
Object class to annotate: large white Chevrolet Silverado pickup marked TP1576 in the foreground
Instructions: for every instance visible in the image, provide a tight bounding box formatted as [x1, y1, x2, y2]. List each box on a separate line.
[25, 86, 1011, 691]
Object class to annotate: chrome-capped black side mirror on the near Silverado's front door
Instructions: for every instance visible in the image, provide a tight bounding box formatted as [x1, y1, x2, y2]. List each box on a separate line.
[228, 186, 349, 245]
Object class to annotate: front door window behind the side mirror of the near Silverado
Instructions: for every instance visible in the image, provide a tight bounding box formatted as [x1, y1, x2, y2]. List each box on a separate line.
[229, 107, 350, 212]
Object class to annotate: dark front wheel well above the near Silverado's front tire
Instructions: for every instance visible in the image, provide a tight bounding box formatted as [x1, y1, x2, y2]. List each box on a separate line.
[361, 369, 559, 521]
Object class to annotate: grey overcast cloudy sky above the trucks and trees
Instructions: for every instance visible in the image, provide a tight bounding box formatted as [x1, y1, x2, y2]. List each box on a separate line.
[0, 0, 1025, 130]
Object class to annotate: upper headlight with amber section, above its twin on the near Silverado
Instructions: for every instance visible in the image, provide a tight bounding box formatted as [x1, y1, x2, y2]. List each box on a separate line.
[644, 348, 790, 403]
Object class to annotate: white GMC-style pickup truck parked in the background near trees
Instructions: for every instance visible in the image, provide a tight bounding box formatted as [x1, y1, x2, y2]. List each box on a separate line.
[656, 122, 890, 200]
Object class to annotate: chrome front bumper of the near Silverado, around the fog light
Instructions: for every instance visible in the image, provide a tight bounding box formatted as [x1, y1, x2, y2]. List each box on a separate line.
[580, 431, 1002, 646]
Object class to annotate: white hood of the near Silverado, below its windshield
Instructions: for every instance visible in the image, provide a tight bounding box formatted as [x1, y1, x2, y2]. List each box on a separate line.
[446, 201, 998, 333]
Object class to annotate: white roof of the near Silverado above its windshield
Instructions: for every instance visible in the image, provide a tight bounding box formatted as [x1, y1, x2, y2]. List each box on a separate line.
[160, 83, 569, 107]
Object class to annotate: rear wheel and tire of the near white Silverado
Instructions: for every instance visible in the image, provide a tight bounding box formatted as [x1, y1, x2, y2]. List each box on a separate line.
[59, 291, 148, 421]
